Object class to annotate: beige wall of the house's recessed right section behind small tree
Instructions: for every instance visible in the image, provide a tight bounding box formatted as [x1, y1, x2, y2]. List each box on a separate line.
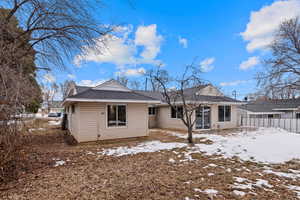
[157, 104, 238, 130]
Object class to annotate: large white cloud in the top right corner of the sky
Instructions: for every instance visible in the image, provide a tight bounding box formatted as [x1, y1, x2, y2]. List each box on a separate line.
[241, 0, 300, 52]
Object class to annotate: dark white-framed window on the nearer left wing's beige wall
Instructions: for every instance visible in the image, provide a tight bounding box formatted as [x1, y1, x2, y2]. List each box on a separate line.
[107, 105, 126, 127]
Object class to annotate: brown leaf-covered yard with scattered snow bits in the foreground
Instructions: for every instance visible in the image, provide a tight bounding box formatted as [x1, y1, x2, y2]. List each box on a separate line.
[0, 121, 300, 200]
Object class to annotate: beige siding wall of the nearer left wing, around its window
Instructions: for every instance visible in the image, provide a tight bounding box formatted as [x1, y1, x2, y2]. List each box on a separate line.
[71, 103, 148, 142]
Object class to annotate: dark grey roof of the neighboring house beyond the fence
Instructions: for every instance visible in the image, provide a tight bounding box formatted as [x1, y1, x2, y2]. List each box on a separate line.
[240, 98, 300, 113]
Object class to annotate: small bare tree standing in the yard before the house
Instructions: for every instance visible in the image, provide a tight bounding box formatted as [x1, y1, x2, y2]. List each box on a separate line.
[148, 63, 205, 143]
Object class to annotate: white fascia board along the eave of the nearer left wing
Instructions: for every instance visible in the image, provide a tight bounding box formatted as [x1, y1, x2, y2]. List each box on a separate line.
[63, 98, 160, 104]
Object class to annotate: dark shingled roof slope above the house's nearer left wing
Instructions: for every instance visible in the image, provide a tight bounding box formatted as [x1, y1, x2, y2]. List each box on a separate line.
[68, 88, 156, 101]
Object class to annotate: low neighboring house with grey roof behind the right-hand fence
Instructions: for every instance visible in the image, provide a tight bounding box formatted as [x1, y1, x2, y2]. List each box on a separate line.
[239, 98, 300, 118]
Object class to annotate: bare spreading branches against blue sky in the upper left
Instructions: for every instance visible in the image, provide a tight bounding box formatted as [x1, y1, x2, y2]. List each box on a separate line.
[0, 0, 112, 68]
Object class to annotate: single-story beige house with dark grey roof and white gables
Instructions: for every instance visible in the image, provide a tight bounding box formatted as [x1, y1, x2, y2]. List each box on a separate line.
[63, 80, 241, 142]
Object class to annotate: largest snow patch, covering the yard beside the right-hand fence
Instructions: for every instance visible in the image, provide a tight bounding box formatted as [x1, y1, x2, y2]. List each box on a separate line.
[171, 128, 300, 163]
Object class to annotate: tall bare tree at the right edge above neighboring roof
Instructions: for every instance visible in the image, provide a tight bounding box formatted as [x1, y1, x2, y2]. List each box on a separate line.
[256, 17, 300, 98]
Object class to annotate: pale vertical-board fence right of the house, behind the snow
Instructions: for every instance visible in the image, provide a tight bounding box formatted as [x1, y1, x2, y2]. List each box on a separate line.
[239, 116, 300, 133]
